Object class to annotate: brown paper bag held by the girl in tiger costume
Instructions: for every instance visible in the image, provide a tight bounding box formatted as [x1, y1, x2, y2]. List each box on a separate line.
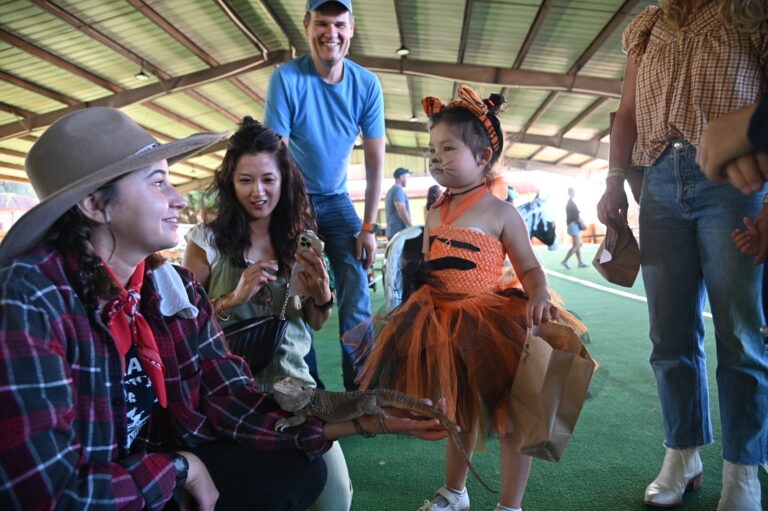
[511, 323, 596, 461]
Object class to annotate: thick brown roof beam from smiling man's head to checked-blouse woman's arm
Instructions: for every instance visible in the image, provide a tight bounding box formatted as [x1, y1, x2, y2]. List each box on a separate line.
[350, 56, 621, 98]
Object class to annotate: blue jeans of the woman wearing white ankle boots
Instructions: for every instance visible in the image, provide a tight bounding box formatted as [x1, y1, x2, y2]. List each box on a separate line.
[640, 141, 768, 465]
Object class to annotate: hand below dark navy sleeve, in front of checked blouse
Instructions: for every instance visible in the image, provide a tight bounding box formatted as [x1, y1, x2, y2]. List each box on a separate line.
[696, 105, 755, 182]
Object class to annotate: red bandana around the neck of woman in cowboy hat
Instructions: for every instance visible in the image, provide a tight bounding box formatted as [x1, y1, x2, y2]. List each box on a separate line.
[102, 261, 168, 408]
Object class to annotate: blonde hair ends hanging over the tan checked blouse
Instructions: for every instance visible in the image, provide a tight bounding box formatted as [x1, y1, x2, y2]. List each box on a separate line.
[659, 0, 768, 32]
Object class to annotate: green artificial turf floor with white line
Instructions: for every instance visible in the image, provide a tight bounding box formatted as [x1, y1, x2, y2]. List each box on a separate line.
[315, 245, 768, 511]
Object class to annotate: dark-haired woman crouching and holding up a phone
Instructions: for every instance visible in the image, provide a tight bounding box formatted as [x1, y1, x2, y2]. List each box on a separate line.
[182, 117, 352, 511]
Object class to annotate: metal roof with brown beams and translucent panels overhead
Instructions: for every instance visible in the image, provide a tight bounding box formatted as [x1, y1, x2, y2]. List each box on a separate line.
[0, 0, 654, 191]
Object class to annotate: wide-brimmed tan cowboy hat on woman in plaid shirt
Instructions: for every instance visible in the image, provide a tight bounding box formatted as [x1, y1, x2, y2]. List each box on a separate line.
[0, 107, 229, 266]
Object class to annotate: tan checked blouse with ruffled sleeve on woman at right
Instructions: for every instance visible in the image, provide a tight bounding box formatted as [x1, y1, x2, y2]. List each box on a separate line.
[622, 1, 768, 167]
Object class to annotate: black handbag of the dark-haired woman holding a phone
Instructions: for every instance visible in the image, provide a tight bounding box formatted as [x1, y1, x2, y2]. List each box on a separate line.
[223, 283, 290, 375]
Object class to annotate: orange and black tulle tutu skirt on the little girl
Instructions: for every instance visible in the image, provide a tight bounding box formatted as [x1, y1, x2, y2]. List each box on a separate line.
[360, 285, 527, 431]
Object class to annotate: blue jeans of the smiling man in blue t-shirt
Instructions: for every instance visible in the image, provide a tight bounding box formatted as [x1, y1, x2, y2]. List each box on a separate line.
[310, 193, 371, 390]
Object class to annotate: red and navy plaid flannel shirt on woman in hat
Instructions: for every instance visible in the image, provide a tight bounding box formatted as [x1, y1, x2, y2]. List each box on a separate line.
[0, 246, 330, 511]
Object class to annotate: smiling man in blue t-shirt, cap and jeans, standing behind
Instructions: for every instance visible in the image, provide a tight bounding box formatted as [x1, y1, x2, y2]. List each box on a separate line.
[264, 0, 384, 389]
